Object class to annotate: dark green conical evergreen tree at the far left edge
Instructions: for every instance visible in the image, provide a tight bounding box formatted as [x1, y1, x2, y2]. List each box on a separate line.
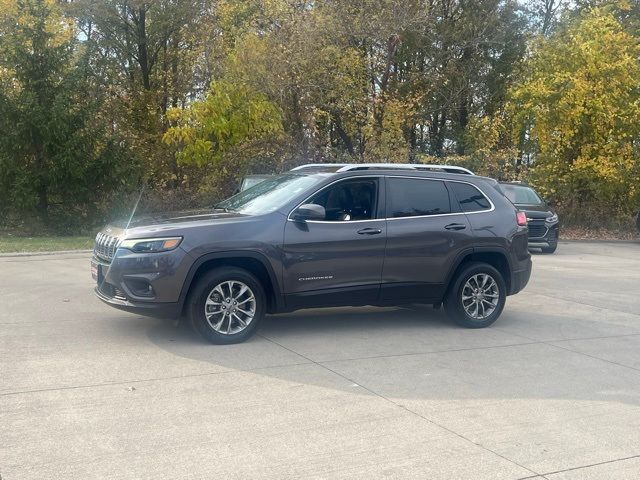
[0, 0, 131, 227]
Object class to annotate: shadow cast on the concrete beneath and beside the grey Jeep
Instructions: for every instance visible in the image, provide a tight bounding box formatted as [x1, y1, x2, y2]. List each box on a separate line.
[147, 305, 640, 405]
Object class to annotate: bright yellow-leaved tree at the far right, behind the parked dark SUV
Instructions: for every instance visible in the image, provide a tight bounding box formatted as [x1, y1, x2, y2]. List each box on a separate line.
[510, 9, 640, 225]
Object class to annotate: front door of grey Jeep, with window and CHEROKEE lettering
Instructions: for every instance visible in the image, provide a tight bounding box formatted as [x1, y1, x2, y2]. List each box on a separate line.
[283, 176, 386, 308]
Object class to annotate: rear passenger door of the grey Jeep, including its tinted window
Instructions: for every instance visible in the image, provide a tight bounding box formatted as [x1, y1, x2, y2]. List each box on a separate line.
[381, 176, 473, 303]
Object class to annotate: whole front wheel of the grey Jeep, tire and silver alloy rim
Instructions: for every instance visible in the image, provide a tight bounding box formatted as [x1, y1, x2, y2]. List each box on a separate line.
[189, 267, 266, 344]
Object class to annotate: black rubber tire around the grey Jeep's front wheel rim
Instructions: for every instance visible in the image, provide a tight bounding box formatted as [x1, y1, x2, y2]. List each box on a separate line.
[188, 267, 266, 345]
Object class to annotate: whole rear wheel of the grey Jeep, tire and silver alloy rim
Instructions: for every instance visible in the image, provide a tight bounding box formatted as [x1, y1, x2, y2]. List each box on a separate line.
[444, 262, 507, 328]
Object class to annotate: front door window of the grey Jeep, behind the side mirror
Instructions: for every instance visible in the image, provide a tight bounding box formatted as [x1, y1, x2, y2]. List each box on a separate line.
[305, 178, 378, 222]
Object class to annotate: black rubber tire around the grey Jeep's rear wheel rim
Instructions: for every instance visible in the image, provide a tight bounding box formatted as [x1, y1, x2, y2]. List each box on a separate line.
[444, 262, 507, 328]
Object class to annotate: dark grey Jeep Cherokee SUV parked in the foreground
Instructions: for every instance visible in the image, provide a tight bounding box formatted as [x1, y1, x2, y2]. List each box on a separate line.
[92, 164, 531, 343]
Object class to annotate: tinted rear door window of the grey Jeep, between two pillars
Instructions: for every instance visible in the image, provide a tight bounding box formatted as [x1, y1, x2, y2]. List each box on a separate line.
[387, 177, 451, 218]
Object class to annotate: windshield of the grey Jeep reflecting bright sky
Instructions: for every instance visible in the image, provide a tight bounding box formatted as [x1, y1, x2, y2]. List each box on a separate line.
[215, 173, 322, 215]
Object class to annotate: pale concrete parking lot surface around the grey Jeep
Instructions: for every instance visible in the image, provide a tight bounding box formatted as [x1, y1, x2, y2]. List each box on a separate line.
[0, 243, 640, 480]
